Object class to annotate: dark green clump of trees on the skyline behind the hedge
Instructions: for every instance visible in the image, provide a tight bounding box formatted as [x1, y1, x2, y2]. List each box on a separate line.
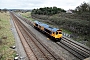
[32, 6, 66, 15]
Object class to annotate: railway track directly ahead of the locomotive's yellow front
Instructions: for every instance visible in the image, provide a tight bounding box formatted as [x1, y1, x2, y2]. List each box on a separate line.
[56, 39, 90, 60]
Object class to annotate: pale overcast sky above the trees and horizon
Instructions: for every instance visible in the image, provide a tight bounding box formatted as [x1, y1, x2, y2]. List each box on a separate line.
[0, 0, 90, 10]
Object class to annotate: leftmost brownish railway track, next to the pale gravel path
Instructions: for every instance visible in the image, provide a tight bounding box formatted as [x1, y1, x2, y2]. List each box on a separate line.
[11, 13, 36, 60]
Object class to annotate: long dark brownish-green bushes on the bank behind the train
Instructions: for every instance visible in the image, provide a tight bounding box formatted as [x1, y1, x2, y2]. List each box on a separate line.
[32, 14, 90, 35]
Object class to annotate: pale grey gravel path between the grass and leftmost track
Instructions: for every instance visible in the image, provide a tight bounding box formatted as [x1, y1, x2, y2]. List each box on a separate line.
[10, 20, 28, 60]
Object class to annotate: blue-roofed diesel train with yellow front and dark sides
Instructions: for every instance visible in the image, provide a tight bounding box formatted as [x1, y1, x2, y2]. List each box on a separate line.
[33, 21, 62, 41]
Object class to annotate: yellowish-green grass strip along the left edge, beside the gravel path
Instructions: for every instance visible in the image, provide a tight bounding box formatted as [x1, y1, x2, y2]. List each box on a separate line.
[0, 12, 16, 60]
